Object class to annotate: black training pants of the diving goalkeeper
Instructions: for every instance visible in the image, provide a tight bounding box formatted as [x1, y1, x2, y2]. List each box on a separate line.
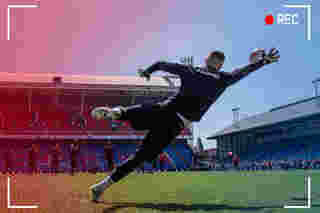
[111, 104, 184, 182]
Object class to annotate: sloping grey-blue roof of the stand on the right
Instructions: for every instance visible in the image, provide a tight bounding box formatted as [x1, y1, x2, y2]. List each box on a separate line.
[207, 97, 320, 139]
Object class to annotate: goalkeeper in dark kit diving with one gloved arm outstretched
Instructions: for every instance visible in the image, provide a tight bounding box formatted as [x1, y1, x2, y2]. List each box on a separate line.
[90, 48, 280, 202]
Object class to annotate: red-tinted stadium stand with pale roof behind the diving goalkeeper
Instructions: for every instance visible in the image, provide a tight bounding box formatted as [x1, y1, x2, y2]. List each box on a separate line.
[0, 73, 192, 172]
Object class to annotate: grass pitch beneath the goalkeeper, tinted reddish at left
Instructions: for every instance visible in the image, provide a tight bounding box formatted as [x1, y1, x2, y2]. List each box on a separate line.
[0, 171, 320, 213]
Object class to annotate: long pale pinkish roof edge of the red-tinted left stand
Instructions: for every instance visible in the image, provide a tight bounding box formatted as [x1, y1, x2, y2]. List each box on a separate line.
[0, 72, 178, 87]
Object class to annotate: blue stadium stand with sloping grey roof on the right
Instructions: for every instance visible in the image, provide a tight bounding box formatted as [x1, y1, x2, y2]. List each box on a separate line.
[208, 97, 320, 165]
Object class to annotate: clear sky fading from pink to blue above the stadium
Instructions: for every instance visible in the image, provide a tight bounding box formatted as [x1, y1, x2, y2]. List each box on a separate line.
[0, 0, 320, 147]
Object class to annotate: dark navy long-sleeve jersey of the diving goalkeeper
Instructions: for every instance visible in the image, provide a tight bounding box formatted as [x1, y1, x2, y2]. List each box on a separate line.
[145, 61, 263, 121]
